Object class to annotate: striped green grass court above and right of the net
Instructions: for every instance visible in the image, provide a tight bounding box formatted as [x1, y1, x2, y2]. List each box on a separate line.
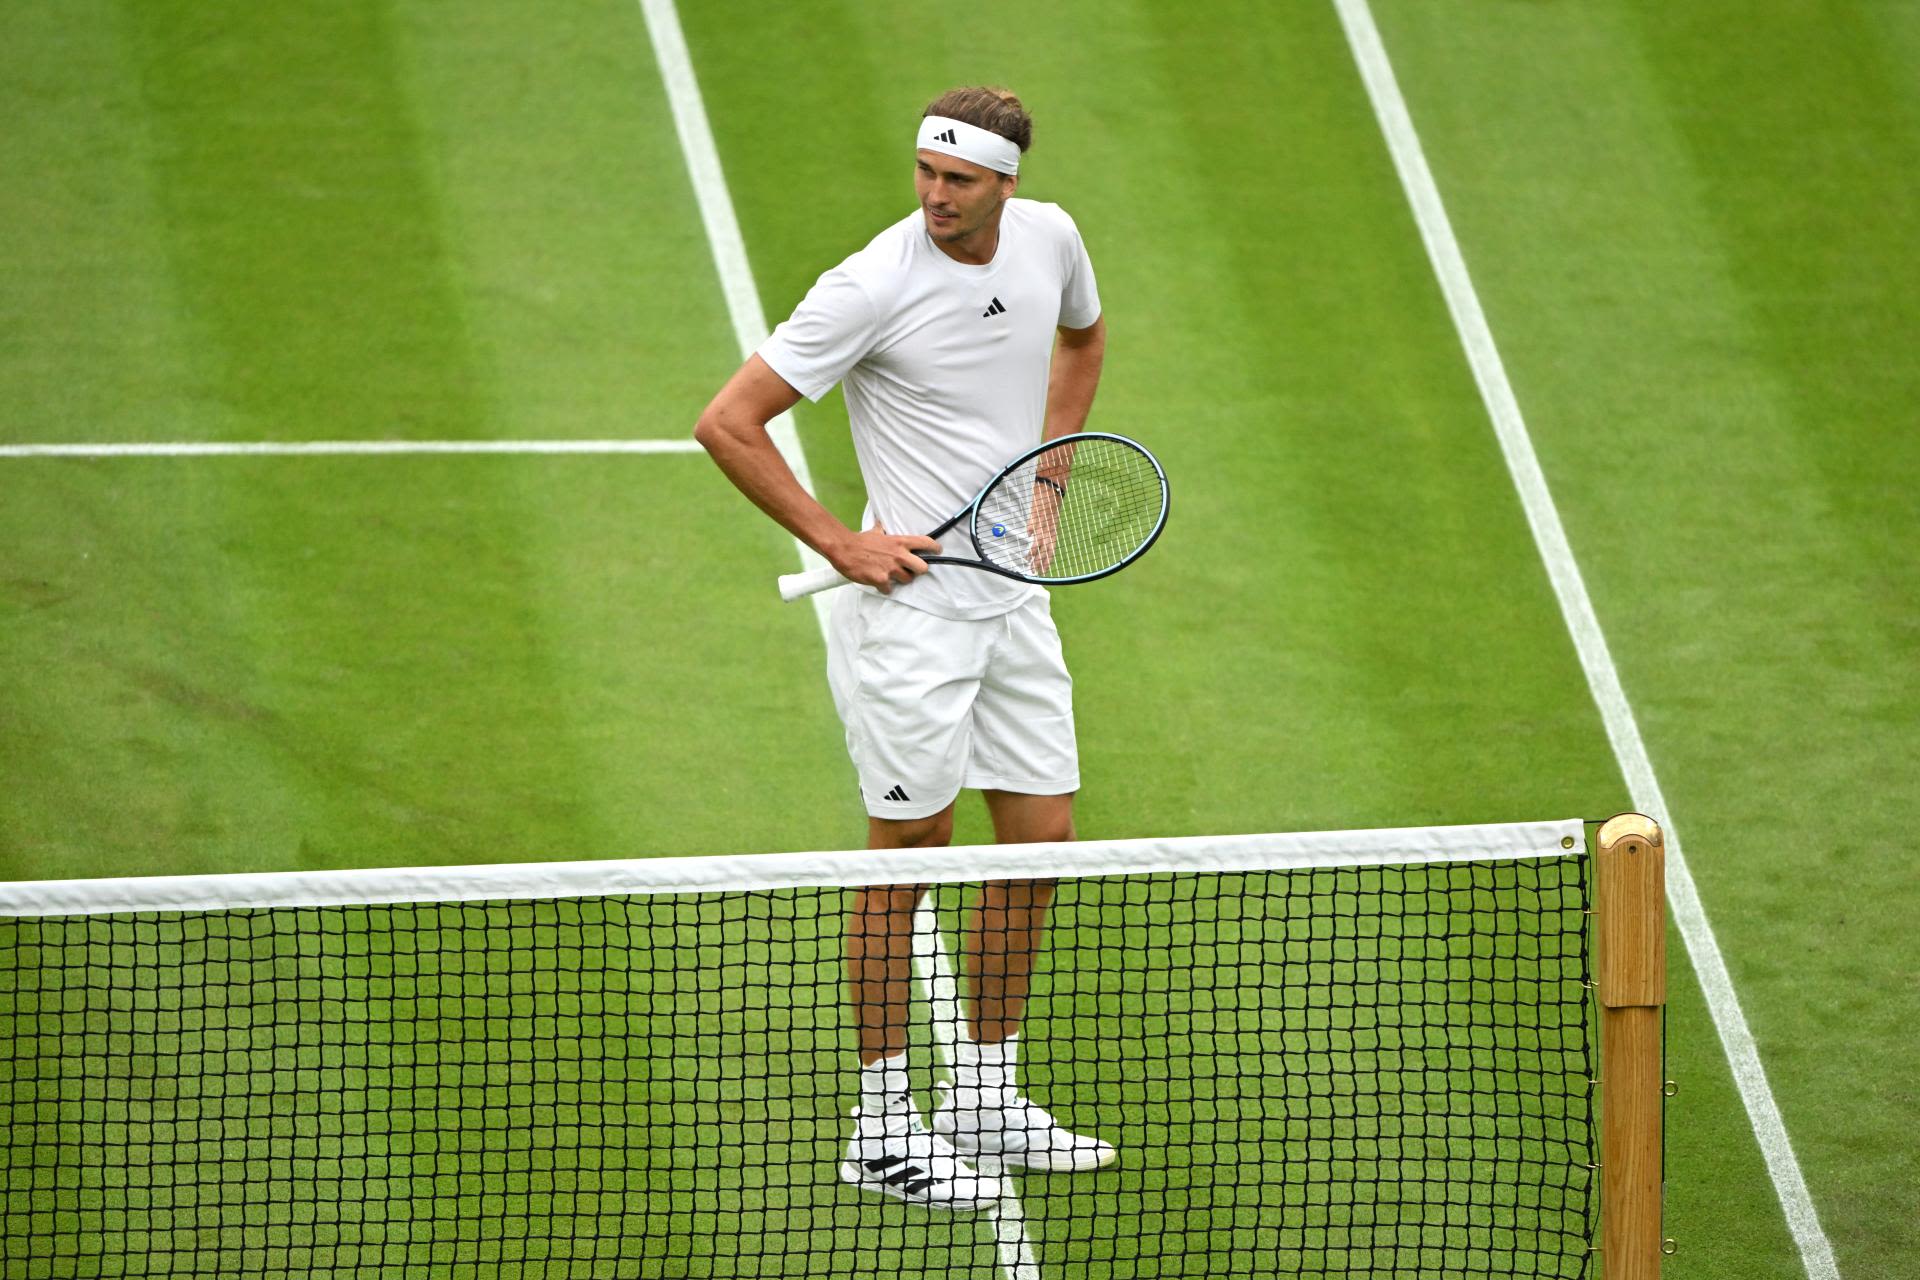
[0, 0, 1920, 1280]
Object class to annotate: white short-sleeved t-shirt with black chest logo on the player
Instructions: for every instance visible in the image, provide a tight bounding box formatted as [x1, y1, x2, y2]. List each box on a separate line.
[760, 200, 1100, 618]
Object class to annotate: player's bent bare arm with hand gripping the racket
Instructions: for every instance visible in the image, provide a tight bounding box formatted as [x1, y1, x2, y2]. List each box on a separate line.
[693, 355, 940, 591]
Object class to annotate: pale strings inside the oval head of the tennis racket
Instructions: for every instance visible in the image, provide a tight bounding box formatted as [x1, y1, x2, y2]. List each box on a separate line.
[975, 438, 1165, 580]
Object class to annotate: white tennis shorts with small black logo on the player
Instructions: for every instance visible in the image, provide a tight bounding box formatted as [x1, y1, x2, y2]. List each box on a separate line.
[828, 591, 1079, 818]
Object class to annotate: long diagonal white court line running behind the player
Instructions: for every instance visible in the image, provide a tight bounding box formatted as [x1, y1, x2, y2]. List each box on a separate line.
[639, 0, 1039, 1280]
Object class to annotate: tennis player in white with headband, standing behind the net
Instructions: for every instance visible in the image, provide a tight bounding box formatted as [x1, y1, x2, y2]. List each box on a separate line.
[695, 88, 1114, 1209]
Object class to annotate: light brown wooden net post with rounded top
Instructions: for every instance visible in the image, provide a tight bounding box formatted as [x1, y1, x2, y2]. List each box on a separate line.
[1594, 814, 1667, 1280]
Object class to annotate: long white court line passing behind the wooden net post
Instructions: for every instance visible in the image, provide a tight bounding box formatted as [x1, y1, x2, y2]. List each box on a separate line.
[1332, 0, 1839, 1280]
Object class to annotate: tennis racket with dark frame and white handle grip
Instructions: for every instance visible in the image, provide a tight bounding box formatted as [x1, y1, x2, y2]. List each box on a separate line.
[780, 432, 1167, 601]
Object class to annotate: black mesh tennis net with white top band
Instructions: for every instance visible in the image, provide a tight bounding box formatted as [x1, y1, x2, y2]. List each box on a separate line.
[0, 821, 1596, 1280]
